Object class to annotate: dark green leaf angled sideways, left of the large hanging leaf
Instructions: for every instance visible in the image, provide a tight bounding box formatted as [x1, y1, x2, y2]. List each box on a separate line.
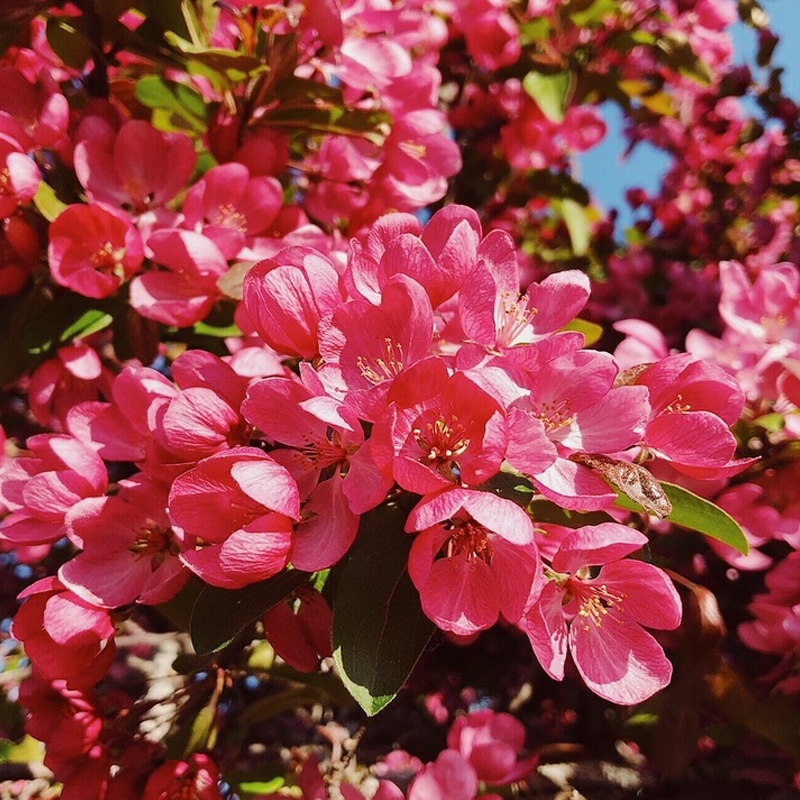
[189, 569, 311, 654]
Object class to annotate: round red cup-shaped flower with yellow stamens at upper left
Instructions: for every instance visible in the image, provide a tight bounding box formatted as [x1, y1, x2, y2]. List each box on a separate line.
[47, 203, 144, 298]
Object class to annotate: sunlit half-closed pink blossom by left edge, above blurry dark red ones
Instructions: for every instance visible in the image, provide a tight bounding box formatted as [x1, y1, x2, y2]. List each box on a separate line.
[11, 578, 116, 688]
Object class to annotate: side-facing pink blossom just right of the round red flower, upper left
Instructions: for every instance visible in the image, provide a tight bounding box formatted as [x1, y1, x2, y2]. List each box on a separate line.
[130, 228, 228, 327]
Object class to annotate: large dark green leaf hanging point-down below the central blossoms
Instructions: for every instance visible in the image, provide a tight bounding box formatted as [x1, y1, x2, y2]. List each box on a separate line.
[333, 506, 434, 716]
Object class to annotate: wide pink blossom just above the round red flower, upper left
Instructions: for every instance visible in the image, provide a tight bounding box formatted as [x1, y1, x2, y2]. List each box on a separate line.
[74, 119, 196, 215]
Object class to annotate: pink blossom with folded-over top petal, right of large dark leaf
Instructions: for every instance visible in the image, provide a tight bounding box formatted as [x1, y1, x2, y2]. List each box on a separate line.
[406, 488, 541, 635]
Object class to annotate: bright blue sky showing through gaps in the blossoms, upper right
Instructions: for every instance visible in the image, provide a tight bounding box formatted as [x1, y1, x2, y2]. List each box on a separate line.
[578, 0, 800, 227]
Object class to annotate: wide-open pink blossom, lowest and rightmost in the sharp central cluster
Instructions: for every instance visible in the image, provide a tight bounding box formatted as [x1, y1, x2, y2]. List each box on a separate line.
[520, 522, 681, 705]
